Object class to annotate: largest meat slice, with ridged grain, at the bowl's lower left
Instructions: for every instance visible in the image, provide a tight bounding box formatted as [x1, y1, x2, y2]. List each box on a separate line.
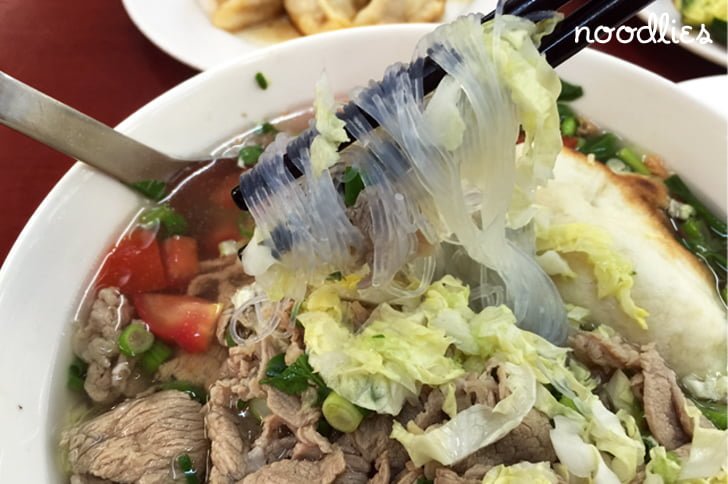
[61, 390, 208, 484]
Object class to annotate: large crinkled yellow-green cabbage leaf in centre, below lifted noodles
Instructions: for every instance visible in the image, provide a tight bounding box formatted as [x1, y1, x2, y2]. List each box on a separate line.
[298, 286, 464, 415]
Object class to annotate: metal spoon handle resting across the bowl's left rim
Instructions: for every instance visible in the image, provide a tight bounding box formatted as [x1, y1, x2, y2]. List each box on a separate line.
[0, 71, 191, 183]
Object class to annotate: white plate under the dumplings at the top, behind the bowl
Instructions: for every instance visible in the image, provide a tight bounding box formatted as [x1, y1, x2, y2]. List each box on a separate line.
[123, 0, 497, 71]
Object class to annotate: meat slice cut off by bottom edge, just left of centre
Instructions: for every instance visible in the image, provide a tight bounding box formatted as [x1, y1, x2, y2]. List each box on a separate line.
[242, 450, 346, 484]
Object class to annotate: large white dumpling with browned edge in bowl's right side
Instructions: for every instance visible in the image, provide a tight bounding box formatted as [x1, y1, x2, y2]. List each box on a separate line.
[536, 150, 727, 384]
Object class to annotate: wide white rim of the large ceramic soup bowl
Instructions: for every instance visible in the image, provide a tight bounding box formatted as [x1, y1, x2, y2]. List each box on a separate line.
[0, 21, 726, 483]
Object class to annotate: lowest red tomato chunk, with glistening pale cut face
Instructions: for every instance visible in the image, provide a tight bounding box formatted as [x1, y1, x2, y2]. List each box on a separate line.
[133, 294, 222, 353]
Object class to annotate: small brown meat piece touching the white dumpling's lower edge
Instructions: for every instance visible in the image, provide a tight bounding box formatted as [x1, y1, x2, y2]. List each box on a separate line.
[569, 331, 640, 370]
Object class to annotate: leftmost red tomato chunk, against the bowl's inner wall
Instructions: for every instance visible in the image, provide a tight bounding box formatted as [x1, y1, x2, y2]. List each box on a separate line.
[97, 228, 167, 294]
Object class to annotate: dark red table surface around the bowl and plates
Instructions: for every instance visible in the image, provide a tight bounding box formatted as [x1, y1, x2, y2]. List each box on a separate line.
[0, 0, 725, 261]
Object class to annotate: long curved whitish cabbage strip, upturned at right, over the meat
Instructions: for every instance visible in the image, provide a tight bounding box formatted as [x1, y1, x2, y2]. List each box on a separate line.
[391, 363, 536, 466]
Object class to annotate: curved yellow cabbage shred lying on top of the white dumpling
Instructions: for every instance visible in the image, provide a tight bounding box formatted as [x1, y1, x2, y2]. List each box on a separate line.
[536, 223, 649, 329]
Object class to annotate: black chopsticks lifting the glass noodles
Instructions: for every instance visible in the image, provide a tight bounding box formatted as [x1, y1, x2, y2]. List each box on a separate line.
[232, 0, 654, 210]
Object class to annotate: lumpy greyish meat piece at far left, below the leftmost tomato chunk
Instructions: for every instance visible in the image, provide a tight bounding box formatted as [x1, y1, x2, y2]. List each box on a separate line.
[73, 287, 148, 404]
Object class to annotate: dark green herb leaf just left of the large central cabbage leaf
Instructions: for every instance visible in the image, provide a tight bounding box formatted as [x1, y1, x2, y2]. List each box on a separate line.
[260, 353, 329, 401]
